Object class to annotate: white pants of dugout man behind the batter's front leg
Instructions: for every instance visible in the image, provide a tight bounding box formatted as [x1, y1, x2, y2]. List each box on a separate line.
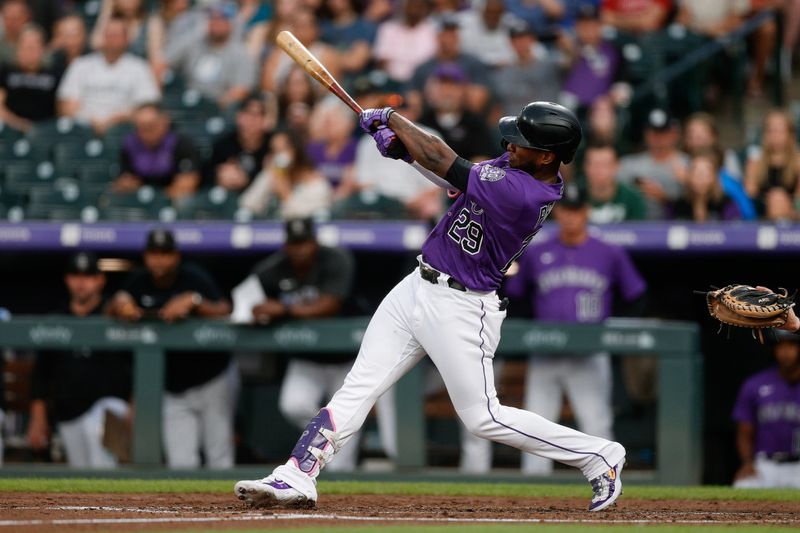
[278, 359, 397, 472]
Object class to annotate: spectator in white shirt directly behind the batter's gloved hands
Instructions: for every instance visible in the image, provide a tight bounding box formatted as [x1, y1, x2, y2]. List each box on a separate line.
[350, 71, 443, 220]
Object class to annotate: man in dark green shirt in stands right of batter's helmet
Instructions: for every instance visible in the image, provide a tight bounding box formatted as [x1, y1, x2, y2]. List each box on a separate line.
[583, 144, 647, 224]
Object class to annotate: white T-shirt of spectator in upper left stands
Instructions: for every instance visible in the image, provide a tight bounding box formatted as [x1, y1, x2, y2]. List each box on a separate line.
[58, 52, 161, 122]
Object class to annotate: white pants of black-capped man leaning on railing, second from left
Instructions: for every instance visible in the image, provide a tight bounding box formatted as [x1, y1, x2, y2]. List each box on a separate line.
[162, 361, 240, 468]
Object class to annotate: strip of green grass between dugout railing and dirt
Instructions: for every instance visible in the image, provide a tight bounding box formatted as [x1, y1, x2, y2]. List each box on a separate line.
[0, 478, 800, 502]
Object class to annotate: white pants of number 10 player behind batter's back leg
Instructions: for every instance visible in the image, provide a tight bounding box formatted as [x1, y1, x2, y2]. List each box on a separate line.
[522, 353, 614, 476]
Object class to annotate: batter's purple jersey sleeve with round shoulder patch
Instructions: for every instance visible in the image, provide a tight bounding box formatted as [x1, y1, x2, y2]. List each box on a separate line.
[467, 161, 533, 224]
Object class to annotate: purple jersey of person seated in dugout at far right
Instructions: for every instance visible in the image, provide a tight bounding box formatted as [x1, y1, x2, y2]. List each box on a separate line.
[733, 368, 800, 454]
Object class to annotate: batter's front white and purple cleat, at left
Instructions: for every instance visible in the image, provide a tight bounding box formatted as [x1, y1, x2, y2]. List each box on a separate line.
[233, 465, 317, 508]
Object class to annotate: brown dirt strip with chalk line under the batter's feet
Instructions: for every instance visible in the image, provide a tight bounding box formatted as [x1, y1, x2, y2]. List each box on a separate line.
[0, 493, 800, 533]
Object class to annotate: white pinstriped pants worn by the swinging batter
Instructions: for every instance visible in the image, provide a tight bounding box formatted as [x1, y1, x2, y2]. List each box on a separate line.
[327, 269, 625, 479]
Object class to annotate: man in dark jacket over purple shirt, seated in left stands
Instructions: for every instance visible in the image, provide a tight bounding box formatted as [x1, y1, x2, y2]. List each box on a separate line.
[113, 104, 200, 201]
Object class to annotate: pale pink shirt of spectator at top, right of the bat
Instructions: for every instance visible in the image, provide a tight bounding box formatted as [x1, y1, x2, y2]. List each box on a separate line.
[373, 20, 436, 81]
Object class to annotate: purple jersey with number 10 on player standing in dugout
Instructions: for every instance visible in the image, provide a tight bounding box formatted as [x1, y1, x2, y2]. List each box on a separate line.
[506, 237, 647, 322]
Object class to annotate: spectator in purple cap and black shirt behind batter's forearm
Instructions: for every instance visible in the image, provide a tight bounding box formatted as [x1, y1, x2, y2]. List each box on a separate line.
[419, 63, 494, 161]
